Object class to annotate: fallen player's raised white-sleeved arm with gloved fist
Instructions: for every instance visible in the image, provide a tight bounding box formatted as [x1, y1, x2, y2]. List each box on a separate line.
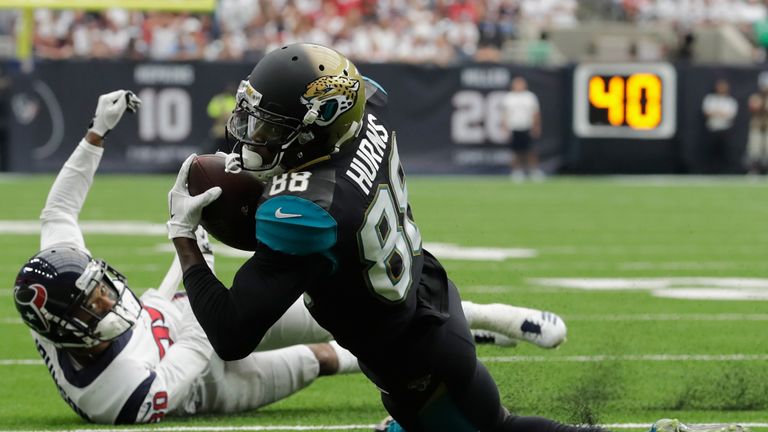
[40, 90, 141, 251]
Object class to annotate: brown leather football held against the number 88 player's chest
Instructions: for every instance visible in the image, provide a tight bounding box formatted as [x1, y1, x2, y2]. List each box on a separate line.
[187, 154, 264, 251]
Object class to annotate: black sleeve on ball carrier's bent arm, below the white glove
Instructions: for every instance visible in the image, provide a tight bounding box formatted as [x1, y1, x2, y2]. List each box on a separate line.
[184, 244, 330, 360]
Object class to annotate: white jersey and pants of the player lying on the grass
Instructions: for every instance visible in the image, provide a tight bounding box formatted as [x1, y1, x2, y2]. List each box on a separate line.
[32, 140, 330, 424]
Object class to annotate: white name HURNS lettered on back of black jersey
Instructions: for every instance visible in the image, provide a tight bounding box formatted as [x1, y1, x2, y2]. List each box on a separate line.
[345, 114, 389, 195]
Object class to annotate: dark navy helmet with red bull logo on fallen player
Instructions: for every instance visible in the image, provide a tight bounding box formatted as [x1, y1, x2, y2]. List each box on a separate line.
[13, 247, 141, 348]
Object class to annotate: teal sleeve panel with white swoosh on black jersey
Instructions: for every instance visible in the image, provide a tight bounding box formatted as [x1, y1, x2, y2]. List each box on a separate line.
[256, 195, 337, 255]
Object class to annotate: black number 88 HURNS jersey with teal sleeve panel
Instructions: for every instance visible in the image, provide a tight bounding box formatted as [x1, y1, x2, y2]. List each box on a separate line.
[256, 81, 446, 362]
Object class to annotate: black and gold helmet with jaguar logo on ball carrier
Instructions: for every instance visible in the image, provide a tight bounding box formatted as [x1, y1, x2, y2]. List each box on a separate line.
[227, 43, 365, 180]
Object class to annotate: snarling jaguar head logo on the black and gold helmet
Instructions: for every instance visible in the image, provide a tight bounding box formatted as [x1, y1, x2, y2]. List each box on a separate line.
[301, 75, 360, 126]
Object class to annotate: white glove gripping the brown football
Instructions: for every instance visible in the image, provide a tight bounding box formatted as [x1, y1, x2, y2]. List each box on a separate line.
[168, 153, 221, 240]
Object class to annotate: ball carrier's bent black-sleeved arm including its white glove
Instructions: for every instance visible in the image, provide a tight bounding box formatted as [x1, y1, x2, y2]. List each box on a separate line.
[168, 155, 330, 360]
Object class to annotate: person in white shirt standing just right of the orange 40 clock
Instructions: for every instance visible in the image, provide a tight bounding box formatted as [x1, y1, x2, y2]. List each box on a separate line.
[701, 79, 739, 173]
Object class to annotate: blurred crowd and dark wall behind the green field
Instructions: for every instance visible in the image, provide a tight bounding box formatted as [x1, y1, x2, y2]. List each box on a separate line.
[0, 0, 768, 174]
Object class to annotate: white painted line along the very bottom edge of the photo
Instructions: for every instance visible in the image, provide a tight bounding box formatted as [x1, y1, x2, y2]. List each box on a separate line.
[0, 420, 768, 432]
